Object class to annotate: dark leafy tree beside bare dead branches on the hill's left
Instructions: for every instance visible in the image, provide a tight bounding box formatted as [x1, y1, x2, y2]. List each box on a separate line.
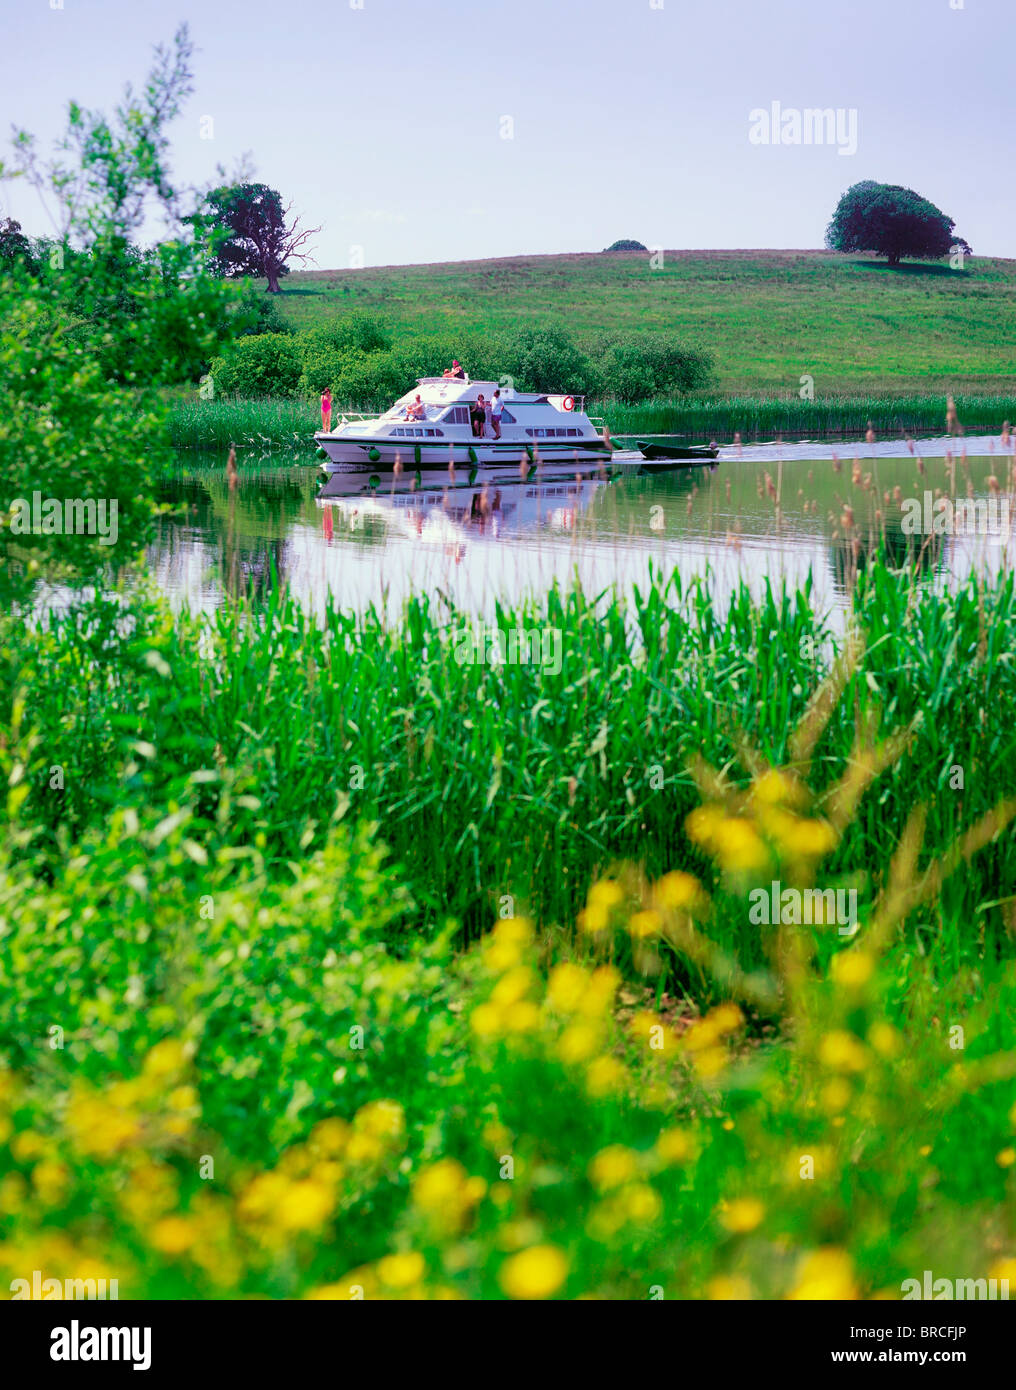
[206, 183, 321, 295]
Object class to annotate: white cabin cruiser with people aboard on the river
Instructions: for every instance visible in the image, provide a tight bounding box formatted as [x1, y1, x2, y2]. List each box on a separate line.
[314, 377, 613, 475]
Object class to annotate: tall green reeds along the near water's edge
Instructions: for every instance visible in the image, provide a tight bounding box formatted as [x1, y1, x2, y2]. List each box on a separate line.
[7, 566, 1016, 978]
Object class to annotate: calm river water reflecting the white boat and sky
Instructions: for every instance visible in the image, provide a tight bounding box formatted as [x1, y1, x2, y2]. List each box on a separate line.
[149, 436, 1016, 625]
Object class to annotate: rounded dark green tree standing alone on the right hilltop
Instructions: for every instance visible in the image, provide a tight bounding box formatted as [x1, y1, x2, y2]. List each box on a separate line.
[826, 179, 972, 265]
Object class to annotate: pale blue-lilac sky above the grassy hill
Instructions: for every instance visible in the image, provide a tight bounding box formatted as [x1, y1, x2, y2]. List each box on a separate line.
[0, 0, 1016, 270]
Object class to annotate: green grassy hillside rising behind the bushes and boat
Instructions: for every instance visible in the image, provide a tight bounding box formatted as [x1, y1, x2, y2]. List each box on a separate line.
[278, 250, 1016, 398]
